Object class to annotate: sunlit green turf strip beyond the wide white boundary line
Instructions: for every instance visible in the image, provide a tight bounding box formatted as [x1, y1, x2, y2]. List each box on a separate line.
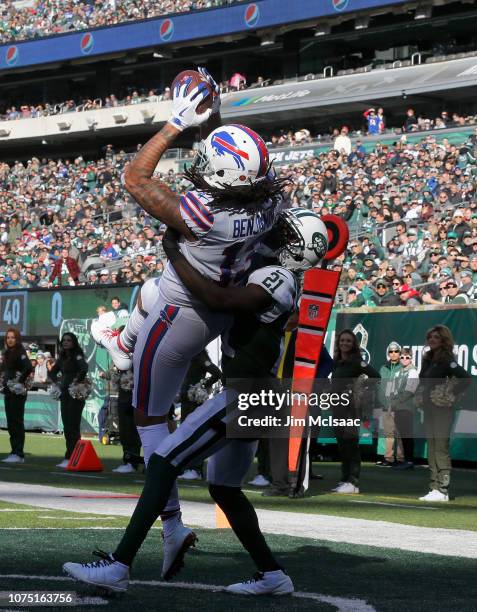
[0, 432, 477, 531]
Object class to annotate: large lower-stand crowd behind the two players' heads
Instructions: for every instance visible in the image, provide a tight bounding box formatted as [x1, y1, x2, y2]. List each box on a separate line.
[0, 122, 477, 306]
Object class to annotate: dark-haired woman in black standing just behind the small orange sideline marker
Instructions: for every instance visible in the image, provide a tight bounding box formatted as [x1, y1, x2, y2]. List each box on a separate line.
[49, 332, 88, 468]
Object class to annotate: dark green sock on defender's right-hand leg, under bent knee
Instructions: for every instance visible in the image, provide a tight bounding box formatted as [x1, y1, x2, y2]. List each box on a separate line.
[209, 484, 283, 572]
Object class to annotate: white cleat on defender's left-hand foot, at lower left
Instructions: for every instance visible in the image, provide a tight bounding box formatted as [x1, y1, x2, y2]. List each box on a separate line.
[63, 551, 129, 592]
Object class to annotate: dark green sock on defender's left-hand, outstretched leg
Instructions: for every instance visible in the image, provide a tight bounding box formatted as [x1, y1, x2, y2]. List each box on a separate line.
[113, 453, 179, 566]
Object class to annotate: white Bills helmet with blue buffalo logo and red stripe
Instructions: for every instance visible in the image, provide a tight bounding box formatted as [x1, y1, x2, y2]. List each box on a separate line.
[194, 124, 269, 189]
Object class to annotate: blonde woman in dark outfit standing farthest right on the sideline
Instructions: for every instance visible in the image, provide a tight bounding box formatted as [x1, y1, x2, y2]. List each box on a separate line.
[418, 325, 470, 502]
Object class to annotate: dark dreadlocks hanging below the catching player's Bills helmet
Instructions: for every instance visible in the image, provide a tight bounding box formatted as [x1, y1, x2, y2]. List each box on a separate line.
[184, 164, 291, 213]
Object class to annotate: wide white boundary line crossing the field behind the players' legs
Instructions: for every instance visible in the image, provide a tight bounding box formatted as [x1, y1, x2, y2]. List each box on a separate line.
[0, 481, 477, 559]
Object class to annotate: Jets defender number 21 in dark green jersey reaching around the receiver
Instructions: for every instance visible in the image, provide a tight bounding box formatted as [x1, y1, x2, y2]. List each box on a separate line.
[63, 209, 327, 595]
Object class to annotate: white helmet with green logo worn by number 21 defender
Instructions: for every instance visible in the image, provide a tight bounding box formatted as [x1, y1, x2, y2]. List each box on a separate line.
[278, 208, 328, 272]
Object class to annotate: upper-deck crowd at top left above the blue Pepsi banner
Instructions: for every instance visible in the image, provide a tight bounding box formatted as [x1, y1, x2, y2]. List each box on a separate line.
[0, 0, 242, 44]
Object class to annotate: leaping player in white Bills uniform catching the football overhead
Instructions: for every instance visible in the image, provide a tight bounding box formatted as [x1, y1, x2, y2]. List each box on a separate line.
[92, 72, 283, 577]
